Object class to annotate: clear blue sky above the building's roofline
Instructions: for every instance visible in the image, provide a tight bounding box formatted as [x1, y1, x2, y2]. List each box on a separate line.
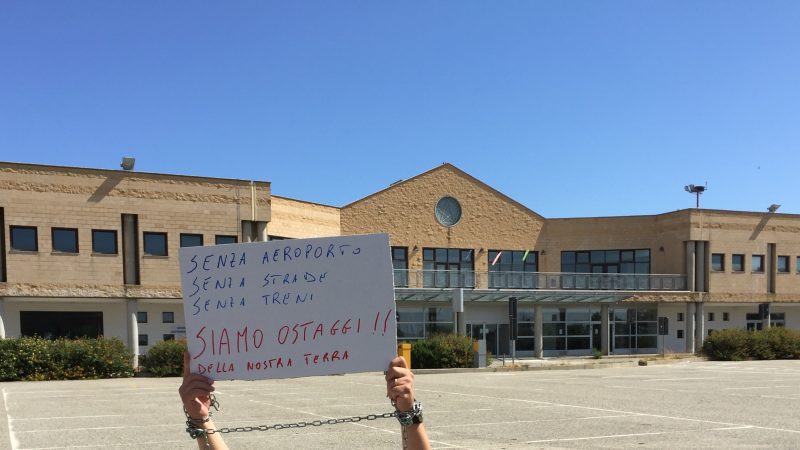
[0, 0, 800, 217]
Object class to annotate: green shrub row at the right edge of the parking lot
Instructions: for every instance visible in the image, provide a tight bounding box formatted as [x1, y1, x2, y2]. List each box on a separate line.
[703, 327, 800, 361]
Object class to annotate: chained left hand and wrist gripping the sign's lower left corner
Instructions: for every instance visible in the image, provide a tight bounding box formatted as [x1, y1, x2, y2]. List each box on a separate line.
[178, 352, 228, 450]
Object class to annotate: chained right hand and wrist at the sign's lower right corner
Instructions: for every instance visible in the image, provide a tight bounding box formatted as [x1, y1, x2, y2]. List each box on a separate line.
[386, 356, 431, 450]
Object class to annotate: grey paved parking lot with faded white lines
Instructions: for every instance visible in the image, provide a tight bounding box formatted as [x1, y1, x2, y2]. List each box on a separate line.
[0, 361, 800, 450]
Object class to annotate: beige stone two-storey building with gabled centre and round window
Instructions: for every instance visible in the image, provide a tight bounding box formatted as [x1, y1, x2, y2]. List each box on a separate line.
[0, 163, 800, 356]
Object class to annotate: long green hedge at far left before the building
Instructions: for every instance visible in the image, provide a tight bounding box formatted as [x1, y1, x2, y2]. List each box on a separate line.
[0, 337, 133, 381]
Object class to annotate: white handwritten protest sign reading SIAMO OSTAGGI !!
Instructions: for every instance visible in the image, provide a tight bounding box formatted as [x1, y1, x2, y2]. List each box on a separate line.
[180, 234, 397, 380]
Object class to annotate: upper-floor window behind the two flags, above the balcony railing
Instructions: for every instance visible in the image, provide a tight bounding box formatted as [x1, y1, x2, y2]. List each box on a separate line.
[488, 250, 538, 289]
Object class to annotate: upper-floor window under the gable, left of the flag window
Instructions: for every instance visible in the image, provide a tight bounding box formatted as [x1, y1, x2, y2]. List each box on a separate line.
[422, 248, 475, 287]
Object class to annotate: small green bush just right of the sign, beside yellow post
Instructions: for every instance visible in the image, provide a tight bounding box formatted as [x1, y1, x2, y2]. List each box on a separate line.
[411, 334, 472, 369]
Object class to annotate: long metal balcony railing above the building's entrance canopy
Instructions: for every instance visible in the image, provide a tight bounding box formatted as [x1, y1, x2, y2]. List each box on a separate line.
[394, 270, 686, 291]
